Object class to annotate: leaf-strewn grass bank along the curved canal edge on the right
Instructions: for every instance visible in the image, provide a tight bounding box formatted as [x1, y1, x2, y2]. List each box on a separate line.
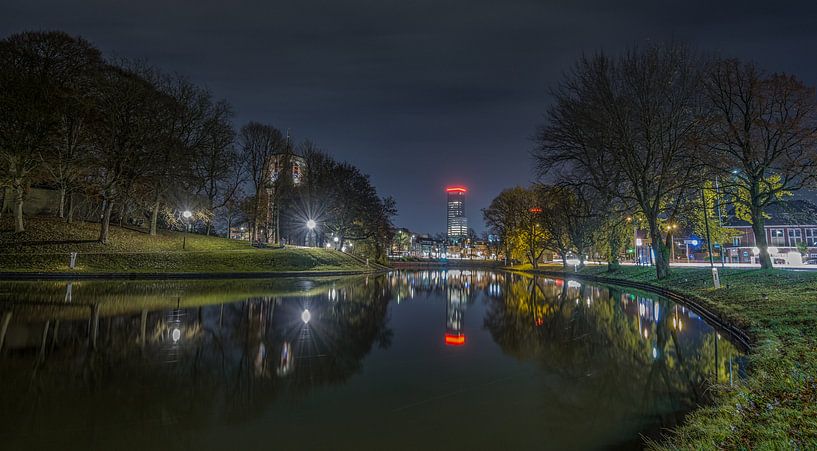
[520, 267, 817, 449]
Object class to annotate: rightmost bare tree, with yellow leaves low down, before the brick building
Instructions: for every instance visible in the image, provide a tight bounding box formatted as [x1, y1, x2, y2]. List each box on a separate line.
[706, 59, 817, 268]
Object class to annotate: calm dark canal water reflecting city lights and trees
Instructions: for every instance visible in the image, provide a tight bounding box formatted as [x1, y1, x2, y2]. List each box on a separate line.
[0, 270, 746, 450]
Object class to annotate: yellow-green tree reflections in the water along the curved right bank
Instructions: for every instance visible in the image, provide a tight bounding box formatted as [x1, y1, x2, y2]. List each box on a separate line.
[485, 276, 737, 440]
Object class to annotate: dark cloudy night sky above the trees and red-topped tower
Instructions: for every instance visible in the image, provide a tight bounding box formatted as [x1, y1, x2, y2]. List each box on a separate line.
[0, 0, 817, 237]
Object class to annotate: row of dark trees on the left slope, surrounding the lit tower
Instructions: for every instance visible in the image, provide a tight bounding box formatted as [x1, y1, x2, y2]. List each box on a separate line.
[0, 32, 396, 261]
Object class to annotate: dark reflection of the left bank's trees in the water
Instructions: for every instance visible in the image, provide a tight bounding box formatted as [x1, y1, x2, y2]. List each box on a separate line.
[0, 277, 391, 449]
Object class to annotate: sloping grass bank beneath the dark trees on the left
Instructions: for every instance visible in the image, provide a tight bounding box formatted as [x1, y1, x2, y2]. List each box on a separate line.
[0, 218, 363, 272]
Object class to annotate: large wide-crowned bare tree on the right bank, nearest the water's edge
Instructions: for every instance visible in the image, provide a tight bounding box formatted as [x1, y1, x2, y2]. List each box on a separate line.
[534, 45, 703, 278]
